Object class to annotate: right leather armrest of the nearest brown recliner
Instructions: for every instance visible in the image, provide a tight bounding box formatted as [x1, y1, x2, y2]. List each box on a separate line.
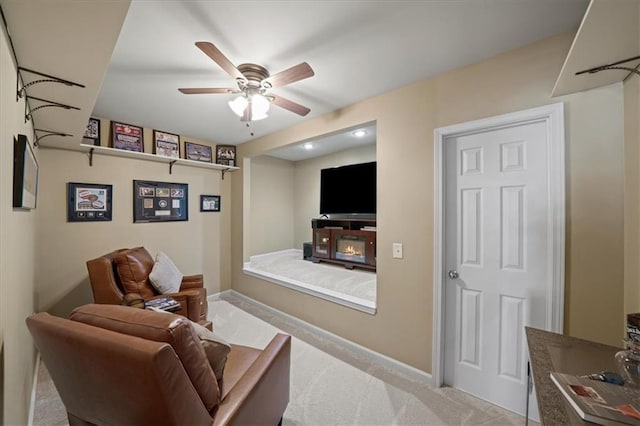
[213, 333, 291, 426]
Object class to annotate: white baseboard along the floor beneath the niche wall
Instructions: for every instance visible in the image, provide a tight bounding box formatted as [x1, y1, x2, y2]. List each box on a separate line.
[207, 290, 433, 386]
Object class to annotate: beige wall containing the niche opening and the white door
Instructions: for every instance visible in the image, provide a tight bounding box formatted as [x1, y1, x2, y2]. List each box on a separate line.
[232, 33, 623, 372]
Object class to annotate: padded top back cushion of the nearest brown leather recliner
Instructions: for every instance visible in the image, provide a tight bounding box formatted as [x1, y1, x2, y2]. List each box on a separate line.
[69, 304, 220, 411]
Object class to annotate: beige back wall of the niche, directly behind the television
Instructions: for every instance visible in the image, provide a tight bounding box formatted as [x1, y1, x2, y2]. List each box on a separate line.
[293, 142, 376, 249]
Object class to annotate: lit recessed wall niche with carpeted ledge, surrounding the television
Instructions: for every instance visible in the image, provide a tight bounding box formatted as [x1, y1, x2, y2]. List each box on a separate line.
[243, 122, 377, 314]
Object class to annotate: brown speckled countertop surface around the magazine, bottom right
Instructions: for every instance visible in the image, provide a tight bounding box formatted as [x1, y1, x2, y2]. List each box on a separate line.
[525, 327, 622, 425]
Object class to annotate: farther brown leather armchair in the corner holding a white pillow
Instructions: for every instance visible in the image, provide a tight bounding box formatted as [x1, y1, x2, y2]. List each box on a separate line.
[87, 247, 211, 329]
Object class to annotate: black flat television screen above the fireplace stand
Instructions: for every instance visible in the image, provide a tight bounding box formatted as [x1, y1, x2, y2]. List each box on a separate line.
[320, 161, 376, 214]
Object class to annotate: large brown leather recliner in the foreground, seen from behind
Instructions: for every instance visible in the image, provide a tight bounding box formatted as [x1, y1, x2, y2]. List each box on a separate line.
[26, 304, 291, 426]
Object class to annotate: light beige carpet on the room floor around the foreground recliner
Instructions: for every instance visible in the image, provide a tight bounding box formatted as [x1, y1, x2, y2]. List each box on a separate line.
[33, 294, 524, 426]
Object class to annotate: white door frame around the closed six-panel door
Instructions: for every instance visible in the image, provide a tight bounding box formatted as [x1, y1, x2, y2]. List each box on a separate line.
[432, 102, 565, 387]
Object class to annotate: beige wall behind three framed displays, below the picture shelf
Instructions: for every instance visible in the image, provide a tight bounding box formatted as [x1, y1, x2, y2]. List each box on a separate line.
[35, 119, 233, 316]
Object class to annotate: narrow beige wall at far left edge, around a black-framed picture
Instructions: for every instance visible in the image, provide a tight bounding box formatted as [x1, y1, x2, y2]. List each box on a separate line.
[0, 22, 37, 425]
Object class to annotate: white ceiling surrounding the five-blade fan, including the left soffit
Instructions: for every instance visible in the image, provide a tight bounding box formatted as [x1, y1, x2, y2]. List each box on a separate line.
[0, 0, 588, 158]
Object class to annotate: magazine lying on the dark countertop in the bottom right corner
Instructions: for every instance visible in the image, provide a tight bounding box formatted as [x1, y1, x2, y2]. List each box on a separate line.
[551, 372, 640, 426]
